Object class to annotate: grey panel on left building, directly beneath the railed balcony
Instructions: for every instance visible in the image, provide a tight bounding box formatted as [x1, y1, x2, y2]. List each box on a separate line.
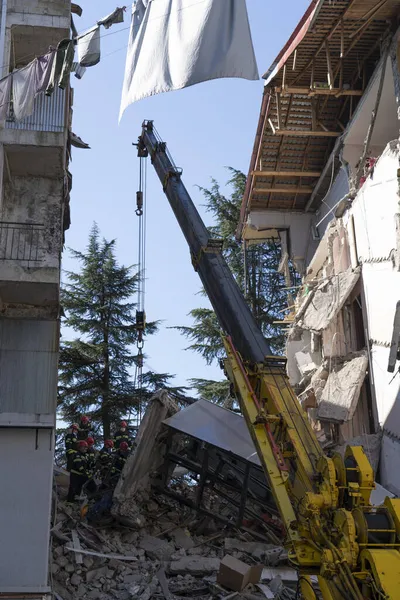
[0, 319, 59, 415]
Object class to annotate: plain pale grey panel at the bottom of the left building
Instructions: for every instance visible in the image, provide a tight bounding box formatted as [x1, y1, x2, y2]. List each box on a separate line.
[0, 428, 54, 597]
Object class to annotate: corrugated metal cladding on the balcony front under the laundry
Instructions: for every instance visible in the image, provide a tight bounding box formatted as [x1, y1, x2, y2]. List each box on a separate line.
[5, 88, 65, 133]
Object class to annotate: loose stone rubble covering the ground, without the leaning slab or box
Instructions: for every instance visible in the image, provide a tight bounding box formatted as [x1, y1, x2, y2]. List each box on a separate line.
[50, 494, 296, 600]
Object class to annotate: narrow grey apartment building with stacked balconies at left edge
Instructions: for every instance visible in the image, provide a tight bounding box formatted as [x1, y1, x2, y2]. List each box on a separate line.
[0, 0, 71, 595]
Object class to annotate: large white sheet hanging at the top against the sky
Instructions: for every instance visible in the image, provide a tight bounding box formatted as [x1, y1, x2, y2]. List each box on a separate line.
[120, 0, 259, 119]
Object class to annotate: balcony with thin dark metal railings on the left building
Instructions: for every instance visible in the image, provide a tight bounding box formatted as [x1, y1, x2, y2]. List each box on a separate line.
[0, 221, 60, 306]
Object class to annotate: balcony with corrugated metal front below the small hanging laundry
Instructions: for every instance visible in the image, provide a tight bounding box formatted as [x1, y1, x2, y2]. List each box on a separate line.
[0, 88, 69, 178]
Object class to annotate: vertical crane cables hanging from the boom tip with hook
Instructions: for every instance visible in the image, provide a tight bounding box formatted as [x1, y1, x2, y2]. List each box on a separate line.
[134, 157, 147, 426]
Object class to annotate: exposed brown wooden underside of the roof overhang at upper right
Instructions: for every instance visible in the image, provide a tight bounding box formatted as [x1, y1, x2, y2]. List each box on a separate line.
[238, 0, 400, 236]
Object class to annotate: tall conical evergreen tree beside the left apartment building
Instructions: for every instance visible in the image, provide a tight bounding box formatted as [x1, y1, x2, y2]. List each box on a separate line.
[59, 225, 158, 438]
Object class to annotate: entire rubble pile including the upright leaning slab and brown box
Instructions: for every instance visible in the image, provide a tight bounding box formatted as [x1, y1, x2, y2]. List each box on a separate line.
[51, 392, 297, 600]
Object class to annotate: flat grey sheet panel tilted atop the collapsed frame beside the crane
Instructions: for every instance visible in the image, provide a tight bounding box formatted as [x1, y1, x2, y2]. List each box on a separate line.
[164, 400, 260, 465]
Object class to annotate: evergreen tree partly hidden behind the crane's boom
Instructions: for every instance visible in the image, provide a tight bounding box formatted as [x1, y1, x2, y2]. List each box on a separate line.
[177, 168, 287, 402]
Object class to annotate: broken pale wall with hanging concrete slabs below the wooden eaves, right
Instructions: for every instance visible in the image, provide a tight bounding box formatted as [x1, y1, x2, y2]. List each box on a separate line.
[287, 142, 400, 492]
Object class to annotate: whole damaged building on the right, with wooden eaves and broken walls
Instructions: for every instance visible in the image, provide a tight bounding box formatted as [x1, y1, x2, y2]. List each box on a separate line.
[238, 0, 400, 495]
